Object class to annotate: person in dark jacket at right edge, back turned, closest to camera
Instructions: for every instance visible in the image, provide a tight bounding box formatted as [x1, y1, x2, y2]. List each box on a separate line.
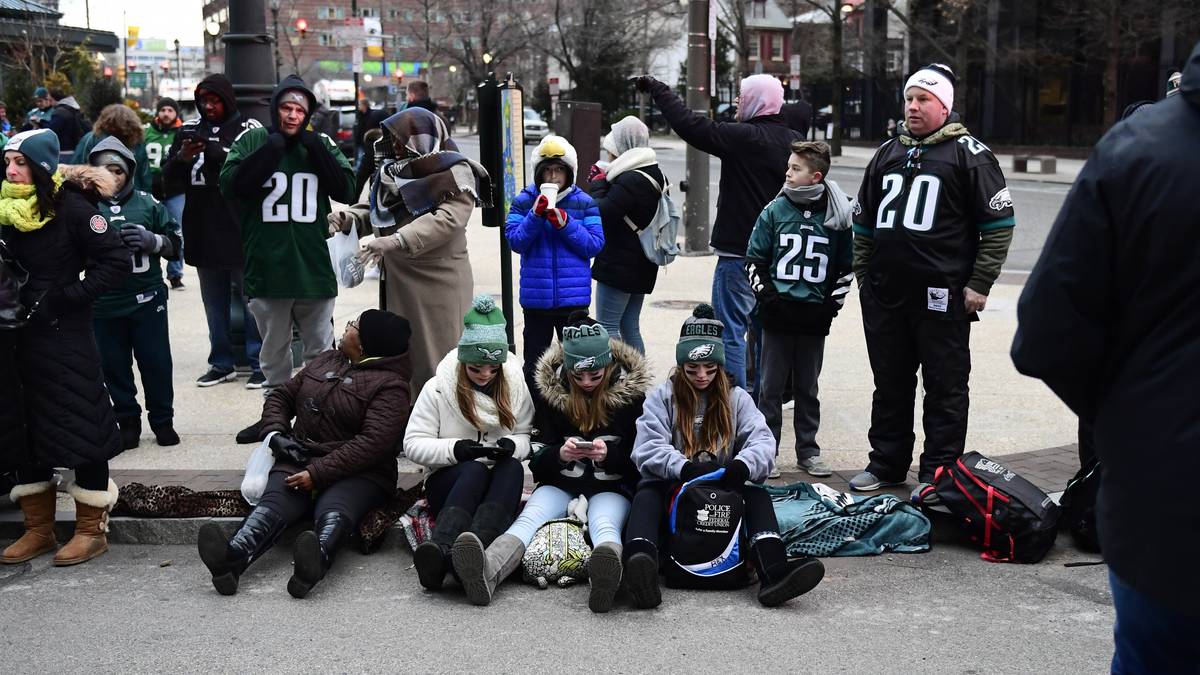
[1013, 43, 1200, 673]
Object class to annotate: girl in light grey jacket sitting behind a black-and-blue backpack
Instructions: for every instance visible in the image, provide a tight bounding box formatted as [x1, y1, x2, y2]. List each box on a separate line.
[625, 305, 824, 609]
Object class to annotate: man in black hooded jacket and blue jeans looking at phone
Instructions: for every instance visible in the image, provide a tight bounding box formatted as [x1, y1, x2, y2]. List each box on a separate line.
[162, 74, 266, 389]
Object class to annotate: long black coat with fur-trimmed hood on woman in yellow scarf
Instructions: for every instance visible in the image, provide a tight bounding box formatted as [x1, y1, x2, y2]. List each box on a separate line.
[0, 165, 132, 468]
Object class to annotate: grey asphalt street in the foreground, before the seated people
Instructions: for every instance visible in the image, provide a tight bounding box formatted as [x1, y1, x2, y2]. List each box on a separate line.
[0, 538, 1112, 674]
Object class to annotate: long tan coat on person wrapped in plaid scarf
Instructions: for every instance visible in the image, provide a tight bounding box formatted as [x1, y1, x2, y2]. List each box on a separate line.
[350, 192, 475, 391]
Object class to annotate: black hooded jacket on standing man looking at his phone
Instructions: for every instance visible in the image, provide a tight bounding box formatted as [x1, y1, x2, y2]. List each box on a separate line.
[162, 74, 263, 271]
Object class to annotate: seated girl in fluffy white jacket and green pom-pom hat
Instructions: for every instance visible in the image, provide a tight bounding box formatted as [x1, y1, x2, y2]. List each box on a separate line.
[404, 295, 533, 591]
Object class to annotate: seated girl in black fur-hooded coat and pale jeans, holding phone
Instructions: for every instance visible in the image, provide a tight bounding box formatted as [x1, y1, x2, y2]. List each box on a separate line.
[454, 312, 650, 613]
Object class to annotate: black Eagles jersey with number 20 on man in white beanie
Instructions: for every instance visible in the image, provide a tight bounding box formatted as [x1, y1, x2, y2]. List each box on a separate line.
[854, 136, 1015, 312]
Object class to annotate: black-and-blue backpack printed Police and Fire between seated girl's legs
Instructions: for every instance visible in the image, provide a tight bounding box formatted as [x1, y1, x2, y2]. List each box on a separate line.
[664, 468, 751, 589]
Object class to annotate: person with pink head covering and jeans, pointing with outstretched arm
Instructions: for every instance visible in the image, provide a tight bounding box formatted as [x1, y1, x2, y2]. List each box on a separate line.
[635, 74, 804, 393]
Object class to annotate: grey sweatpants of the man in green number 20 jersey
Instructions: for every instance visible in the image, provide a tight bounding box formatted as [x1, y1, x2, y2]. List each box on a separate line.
[250, 298, 336, 388]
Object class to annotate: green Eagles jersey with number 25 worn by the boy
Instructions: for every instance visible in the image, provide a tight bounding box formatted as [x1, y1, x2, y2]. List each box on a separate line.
[746, 195, 853, 304]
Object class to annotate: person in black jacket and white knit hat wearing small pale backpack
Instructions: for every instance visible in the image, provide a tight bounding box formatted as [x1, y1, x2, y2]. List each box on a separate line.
[588, 117, 666, 354]
